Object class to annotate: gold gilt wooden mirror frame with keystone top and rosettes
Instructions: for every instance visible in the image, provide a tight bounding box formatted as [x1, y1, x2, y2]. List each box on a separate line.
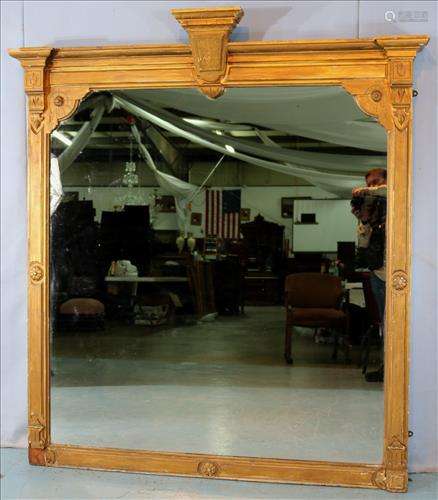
[9, 7, 429, 492]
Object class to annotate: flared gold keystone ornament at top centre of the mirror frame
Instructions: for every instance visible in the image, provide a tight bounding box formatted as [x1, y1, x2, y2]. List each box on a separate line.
[172, 7, 243, 99]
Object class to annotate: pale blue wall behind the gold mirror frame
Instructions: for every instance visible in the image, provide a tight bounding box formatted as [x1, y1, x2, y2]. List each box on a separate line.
[1, 0, 438, 471]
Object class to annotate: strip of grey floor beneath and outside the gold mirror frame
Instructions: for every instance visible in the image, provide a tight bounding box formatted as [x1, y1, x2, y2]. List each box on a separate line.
[0, 449, 438, 500]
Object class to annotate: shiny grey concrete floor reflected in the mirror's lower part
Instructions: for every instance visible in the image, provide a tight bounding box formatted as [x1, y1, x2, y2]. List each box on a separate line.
[52, 307, 383, 463]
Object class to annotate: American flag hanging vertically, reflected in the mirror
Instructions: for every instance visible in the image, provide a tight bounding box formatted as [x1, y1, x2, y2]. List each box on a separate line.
[205, 189, 240, 239]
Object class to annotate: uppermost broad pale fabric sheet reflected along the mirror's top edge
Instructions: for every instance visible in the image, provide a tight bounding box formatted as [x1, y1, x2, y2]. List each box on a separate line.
[119, 86, 386, 152]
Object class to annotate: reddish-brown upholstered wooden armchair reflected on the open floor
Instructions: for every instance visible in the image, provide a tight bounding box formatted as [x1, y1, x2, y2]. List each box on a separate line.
[284, 273, 348, 364]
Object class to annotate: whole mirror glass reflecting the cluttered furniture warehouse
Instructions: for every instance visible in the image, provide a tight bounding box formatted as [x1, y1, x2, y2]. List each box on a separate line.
[50, 87, 386, 462]
